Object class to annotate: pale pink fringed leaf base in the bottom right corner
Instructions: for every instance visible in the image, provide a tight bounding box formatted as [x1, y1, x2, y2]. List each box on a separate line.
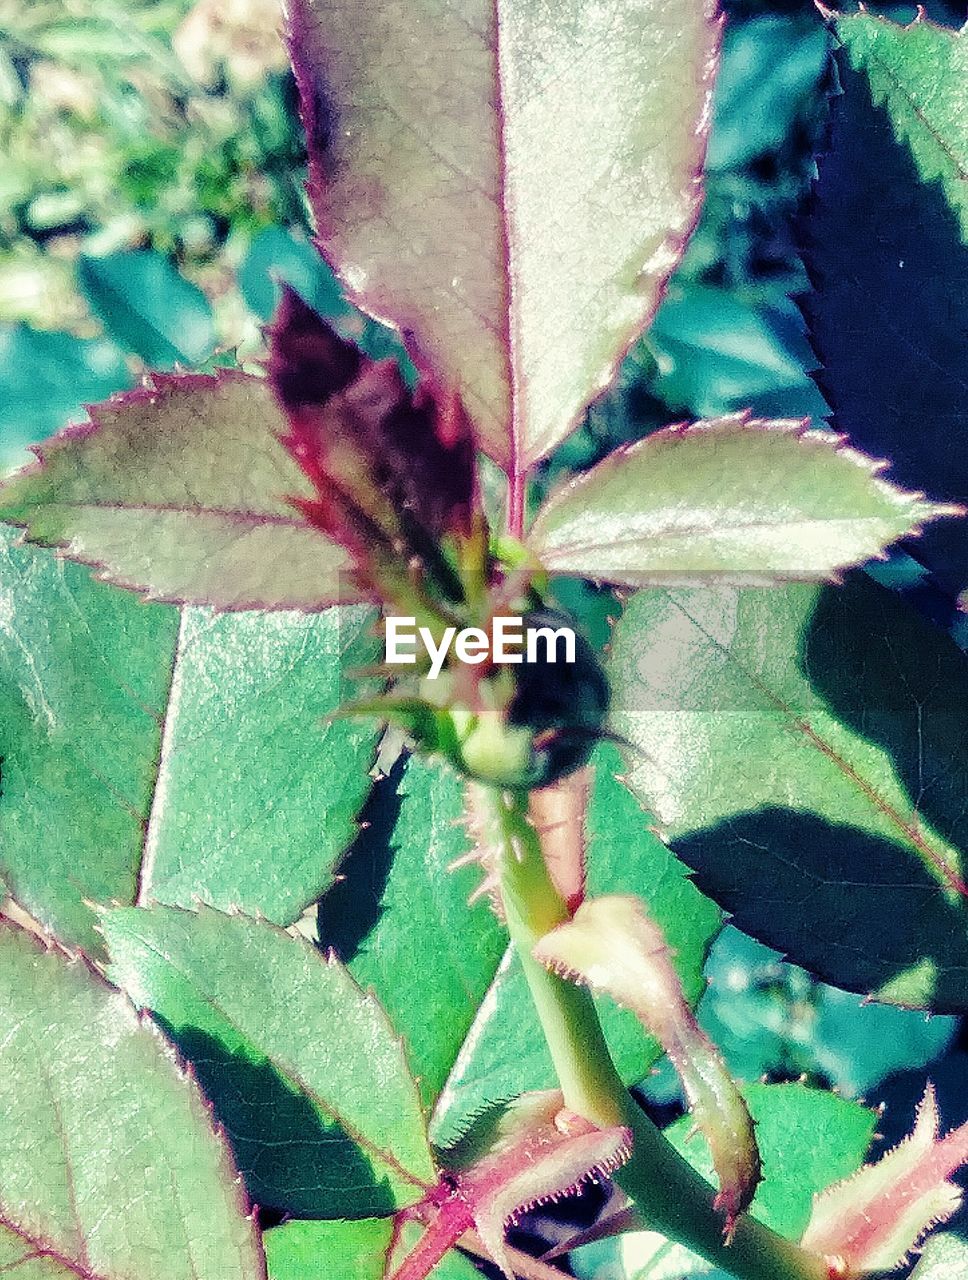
[802, 1085, 968, 1280]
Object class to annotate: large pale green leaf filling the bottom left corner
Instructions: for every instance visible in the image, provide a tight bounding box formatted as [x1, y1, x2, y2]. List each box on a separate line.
[0, 922, 265, 1280]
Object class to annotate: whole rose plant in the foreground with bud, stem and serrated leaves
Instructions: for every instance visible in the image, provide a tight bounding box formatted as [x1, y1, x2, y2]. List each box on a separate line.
[0, 0, 968, 1280]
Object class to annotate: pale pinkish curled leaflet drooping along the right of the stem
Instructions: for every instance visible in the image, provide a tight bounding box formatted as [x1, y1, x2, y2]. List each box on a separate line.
[534, 895, 761, 1236]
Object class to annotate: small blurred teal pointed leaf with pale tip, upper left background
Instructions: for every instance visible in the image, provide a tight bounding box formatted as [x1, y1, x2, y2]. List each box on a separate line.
[77, 250, 215, 369]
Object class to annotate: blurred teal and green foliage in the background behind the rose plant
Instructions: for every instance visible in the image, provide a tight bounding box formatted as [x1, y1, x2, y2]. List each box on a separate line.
[0, 0, 968, 1274]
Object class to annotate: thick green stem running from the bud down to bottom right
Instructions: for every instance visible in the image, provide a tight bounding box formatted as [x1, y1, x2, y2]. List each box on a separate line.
[481, 788, 828, 1280]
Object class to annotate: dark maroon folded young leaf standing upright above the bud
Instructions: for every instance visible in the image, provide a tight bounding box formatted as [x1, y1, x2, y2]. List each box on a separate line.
[269, 288, 475, 554]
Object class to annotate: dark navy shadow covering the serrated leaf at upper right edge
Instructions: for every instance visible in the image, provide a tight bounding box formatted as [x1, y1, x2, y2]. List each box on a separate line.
[803, 58, 968, 591]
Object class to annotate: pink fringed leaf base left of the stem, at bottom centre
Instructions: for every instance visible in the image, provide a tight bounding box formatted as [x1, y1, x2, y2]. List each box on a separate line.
[388, 1092, 631, 1280]
